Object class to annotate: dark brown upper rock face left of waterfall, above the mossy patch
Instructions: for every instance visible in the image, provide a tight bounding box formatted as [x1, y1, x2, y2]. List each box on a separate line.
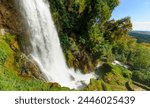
[0, 0, 31, 54]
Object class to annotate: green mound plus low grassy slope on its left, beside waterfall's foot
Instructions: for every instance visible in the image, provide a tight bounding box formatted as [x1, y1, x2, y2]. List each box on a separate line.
[84, 63, 132, 91]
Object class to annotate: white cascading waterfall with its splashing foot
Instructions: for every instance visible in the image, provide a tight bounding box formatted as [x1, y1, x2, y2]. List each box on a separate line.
[17, 0, 94, 88]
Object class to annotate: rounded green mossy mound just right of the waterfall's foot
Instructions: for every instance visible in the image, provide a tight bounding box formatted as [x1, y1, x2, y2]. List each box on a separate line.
[96, 63, 132, 91]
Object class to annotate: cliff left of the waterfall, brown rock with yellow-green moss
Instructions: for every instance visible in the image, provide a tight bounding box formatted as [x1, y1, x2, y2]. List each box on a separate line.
[0, 0, 46, 82]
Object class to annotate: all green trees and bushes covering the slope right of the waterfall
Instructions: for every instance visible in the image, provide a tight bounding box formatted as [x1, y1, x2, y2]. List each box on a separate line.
[49, 0, 150, 90]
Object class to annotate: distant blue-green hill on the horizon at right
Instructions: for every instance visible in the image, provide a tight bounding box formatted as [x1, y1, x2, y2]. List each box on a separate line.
[129, 31, 150, 43]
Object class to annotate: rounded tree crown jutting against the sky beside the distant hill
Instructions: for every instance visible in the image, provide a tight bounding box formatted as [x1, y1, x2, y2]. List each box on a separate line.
[104, 17, 132, 43]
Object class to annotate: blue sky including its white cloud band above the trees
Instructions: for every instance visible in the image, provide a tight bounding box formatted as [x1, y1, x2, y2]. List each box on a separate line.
[112, 0, 150, 31]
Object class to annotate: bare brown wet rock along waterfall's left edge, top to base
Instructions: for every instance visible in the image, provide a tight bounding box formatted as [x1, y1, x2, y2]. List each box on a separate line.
[0, 0, 47, 82]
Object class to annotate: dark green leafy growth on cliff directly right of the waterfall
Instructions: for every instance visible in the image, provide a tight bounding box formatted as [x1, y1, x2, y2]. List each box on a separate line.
[49, 0, 119, 73]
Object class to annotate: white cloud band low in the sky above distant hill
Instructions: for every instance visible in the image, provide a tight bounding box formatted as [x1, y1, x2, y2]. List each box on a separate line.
[133, 21, 150, 31]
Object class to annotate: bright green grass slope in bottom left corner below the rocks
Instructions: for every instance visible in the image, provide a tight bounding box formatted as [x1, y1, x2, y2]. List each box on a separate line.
[0, 66, 69, 91]
